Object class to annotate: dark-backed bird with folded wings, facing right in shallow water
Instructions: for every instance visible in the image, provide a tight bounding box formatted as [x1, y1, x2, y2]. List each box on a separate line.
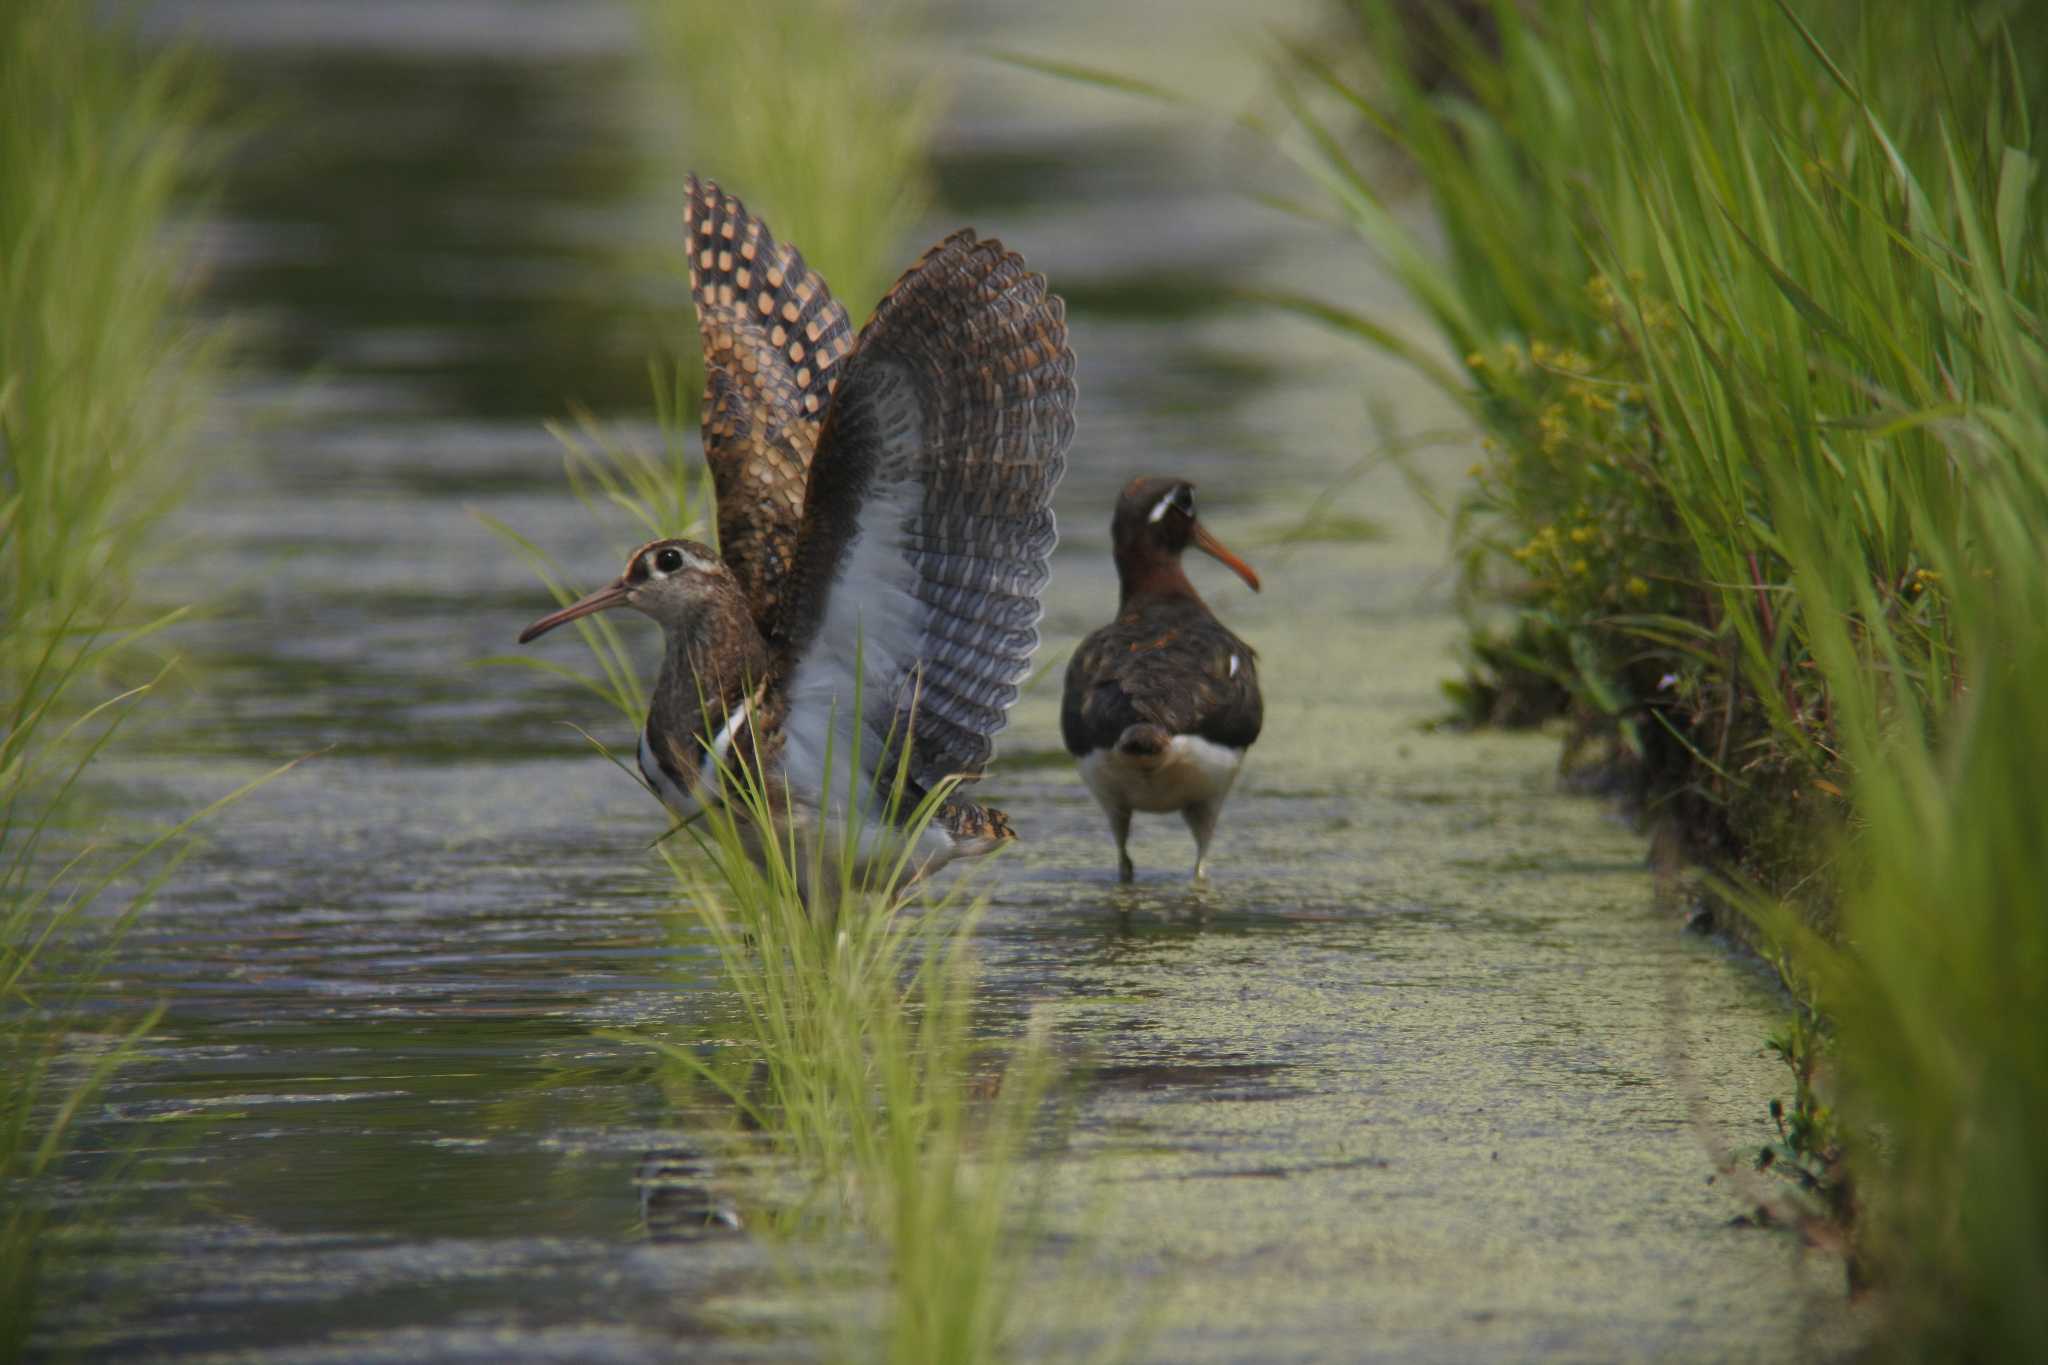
[1059, 479, 1266, 882]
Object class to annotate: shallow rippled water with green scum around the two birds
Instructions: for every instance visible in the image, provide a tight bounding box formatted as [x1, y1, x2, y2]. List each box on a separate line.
[55, 0, 1867, 1361]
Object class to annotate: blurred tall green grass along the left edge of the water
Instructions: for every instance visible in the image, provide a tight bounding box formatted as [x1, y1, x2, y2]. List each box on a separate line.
[0, 0, 227, 1359]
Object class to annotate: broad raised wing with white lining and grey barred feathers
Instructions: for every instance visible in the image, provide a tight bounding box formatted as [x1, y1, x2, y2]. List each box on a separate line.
[780, 231, 1075, 806]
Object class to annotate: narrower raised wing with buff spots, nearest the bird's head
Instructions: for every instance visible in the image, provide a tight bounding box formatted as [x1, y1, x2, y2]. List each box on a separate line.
[682, 176, 854, 630]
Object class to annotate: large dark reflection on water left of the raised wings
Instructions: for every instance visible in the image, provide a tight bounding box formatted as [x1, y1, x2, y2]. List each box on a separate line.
[206, 51, 659, 419]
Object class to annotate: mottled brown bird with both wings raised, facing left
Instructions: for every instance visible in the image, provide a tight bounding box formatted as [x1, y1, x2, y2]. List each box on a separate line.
[520, 176, 1075, 888]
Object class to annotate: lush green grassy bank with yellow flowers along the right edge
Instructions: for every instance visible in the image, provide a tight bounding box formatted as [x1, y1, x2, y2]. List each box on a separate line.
[1290, 0, 2048, 1359]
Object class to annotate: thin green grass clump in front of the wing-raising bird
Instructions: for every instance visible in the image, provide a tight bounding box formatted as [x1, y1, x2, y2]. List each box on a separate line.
[643, 757, 1055, 1361]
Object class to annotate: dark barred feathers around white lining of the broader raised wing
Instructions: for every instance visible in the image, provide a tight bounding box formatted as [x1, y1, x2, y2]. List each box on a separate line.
[780, 229, 1073, 788]
